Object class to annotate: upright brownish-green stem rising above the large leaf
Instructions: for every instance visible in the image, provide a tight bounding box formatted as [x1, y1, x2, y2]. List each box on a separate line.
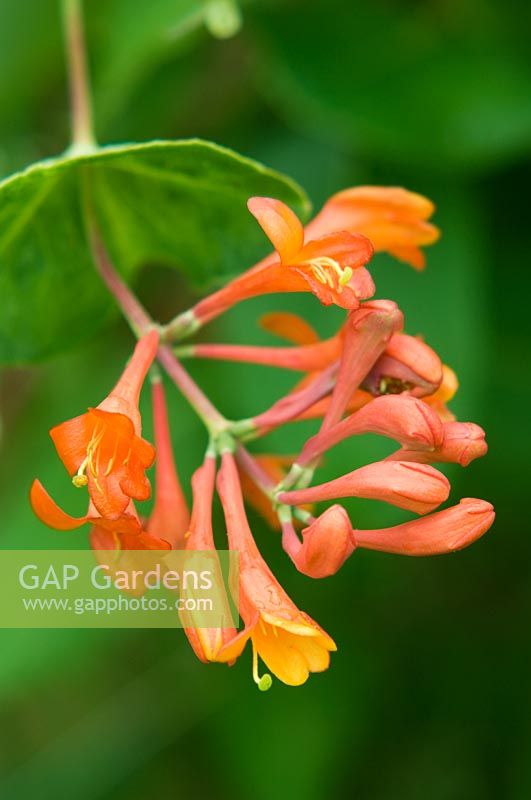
[62, 0, 96, 154]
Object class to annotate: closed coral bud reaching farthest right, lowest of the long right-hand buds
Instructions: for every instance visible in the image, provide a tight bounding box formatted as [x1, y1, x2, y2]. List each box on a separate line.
[354, 497, 495, 556]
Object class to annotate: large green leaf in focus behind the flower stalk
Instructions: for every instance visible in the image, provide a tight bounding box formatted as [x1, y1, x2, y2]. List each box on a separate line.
[0, 140, 308, 363]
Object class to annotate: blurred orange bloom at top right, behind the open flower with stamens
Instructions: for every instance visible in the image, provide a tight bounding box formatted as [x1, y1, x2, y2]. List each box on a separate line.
[306, 186, 440, 270]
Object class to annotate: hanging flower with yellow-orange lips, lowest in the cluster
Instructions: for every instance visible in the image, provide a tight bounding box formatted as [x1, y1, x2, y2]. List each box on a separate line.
[213, 453, 336, 689]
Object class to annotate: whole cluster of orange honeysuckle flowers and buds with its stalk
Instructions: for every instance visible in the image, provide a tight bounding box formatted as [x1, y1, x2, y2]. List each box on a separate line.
[31, 187, 494, 690]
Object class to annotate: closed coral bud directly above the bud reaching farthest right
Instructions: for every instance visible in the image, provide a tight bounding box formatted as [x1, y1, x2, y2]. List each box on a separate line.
[279, 461, 450, 514]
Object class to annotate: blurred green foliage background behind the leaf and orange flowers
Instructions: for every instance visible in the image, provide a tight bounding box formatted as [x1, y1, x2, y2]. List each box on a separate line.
[0, 0, 531, 800]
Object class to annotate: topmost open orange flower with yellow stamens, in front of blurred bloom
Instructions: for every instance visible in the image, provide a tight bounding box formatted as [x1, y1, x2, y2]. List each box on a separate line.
[194, 197, 375, 321]
